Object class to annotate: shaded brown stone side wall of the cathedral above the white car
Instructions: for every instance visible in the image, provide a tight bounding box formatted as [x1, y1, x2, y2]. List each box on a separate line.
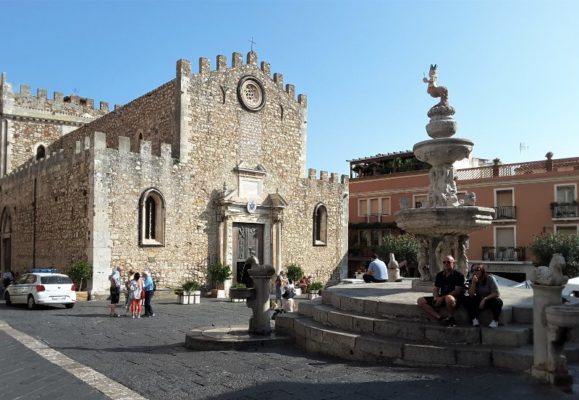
[0, 151, 91, 272]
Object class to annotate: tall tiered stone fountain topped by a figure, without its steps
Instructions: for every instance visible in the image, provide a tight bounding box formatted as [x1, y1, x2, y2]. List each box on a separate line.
[396, 64, 494, 284]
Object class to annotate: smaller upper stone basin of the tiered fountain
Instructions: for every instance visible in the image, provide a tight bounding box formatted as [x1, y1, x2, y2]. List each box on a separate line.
[413, 138, 474, 165]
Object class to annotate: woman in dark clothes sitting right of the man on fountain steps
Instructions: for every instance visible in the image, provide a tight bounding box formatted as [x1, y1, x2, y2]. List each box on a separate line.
[466, 264, 503, 328]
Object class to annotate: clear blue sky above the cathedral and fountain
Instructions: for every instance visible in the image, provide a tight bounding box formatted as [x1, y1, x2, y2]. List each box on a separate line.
[0, 0, 579, 174]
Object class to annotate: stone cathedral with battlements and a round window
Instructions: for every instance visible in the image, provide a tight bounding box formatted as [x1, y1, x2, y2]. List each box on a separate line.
[0, 51, 348, 294]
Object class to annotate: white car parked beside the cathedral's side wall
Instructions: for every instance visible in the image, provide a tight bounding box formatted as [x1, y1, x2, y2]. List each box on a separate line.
[4, 269, 76, 309]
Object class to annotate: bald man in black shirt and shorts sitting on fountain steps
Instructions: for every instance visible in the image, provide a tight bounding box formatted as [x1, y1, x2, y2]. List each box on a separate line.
[417, 255, 465, 326]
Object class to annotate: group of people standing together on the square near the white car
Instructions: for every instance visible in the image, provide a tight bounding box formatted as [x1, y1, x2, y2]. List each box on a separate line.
[109, 267, 155, 318]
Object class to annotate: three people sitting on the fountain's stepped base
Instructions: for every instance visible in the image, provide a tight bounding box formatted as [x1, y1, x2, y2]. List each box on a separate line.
[362, 254, 503, 328]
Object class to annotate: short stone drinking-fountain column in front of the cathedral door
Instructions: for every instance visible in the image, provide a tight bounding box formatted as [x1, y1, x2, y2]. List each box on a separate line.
[247, 265, 275, 335]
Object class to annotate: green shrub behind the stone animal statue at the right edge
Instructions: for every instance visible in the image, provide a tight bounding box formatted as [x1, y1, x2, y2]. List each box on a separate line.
[529, 233, 579, 278]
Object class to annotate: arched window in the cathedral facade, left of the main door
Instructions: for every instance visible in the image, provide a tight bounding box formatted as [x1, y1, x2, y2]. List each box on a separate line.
[139, 189, 165, 246]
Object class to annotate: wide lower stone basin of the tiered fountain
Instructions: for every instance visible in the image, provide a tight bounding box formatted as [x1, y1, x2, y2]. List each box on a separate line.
[395, 206, 495, 236]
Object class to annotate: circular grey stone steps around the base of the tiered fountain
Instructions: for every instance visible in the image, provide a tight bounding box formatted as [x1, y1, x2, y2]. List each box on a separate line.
[275, 283, 579, 371]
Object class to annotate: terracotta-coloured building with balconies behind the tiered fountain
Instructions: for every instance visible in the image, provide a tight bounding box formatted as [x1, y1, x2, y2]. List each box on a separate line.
[349, 152, 579, 280]
